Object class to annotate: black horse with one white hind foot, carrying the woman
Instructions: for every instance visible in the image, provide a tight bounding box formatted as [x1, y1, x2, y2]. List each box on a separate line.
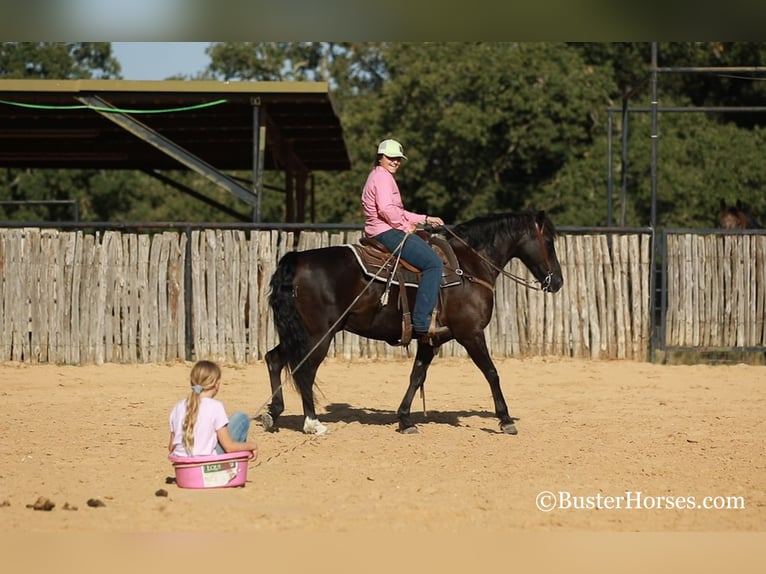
[262, 211, 564, 434]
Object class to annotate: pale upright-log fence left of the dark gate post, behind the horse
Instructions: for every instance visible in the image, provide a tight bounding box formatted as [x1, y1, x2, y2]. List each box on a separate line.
[0, 228, 652, 364]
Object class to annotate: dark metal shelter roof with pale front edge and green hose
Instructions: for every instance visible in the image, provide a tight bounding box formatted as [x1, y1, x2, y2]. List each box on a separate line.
[0, 79, 351, 171]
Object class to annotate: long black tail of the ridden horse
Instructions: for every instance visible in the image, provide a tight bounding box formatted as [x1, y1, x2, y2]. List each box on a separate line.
[269, 251, 309, 382]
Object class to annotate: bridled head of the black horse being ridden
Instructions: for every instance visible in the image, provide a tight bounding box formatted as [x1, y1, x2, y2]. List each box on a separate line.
[517, 211, 564, 293]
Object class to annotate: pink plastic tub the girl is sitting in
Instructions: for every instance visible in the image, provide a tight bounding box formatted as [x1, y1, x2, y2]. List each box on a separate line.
[168, 451, 251, 488]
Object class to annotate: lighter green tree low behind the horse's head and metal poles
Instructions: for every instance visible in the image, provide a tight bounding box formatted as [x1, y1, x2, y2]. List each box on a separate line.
[533, 98, 766, 228]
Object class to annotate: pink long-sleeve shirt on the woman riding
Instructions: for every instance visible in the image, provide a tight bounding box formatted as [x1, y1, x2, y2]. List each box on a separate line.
[362, 165, 426, 237]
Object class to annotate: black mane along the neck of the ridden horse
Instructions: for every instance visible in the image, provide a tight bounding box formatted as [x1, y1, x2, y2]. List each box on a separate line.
[452, 210, 556, 249]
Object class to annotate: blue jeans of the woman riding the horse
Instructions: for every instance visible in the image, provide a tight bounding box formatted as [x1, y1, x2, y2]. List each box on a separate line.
[373, 229, 444, 332]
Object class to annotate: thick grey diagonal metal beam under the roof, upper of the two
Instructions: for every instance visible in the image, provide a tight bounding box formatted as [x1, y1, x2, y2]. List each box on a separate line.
[77, 95, 257, 206]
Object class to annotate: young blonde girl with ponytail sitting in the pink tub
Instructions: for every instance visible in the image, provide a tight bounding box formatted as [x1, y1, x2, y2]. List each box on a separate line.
[168, 361, 258, 459]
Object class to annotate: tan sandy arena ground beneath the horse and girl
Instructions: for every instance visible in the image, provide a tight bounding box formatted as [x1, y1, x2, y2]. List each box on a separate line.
[0, 358, 766, 534]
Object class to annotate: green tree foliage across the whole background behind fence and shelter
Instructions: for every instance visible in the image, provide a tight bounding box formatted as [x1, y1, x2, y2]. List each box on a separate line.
[0, 42, 766, 233]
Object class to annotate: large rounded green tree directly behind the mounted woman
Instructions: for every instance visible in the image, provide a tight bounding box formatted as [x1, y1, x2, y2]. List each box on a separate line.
[316, 43, 609, 225]
